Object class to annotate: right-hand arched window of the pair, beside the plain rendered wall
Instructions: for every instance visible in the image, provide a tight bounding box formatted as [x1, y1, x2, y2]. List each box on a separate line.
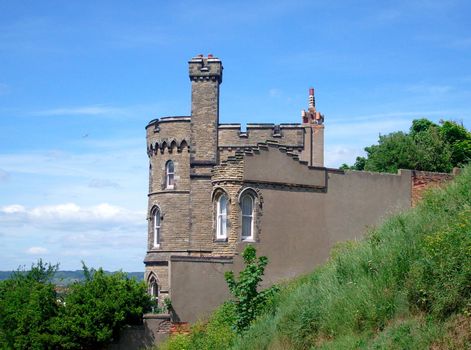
[237, 187, 263, 242]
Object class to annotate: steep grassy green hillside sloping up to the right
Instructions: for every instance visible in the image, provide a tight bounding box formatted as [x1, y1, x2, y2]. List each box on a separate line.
[160, 166, 471, 350]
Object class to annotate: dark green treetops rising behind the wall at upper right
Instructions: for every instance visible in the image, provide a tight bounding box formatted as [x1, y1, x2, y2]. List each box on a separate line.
[341, 119, 471, 173]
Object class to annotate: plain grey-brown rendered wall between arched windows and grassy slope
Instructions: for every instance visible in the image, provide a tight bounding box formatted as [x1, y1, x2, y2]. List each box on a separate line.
[251, 172, 411, 285]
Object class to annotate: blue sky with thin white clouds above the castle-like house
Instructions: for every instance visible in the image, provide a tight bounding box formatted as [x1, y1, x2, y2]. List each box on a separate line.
[0, 0, 471, 271]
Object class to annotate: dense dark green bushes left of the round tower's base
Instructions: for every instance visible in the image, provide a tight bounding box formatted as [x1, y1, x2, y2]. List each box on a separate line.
[0, 260, 150, 349]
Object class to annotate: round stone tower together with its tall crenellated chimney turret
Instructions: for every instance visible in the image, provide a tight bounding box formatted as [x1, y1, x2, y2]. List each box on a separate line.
[144, 55, 222, 300]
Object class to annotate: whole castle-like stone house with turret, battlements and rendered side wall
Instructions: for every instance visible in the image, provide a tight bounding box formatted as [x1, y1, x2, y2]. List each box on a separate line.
[144, 55, 428, 321]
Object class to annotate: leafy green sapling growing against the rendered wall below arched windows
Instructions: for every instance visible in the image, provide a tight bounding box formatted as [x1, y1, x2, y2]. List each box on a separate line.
[224, 245, 276, 332]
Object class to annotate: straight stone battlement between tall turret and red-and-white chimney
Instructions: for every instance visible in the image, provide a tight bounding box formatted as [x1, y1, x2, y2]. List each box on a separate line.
[218, 123, 304, 149]
